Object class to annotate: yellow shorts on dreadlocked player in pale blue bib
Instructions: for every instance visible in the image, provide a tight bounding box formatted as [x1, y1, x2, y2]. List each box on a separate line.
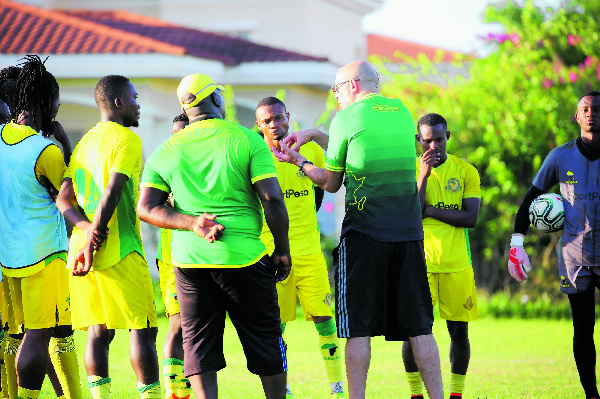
[3, 258, 71, 334]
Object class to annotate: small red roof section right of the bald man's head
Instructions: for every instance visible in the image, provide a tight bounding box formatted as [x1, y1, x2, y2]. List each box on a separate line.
[367, 34, 464, 62]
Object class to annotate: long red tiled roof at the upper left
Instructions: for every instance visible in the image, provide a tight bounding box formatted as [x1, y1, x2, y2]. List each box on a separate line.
[0, 0, 327, 65]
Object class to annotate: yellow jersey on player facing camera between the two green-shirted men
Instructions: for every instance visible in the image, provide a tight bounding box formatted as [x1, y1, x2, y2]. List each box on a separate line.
[260, 142, 325, 257]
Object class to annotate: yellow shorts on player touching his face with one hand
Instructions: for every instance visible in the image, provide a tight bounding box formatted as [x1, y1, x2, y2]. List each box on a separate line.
[427, 267, 479, 321]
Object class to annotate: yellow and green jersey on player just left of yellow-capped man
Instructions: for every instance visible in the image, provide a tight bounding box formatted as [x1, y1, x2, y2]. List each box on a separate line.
[65, 122, 144, 270]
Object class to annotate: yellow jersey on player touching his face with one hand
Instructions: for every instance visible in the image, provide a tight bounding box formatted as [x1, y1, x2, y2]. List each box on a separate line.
[416, 154, 481, 273]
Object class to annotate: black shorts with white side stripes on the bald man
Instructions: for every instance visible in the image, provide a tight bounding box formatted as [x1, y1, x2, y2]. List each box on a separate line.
[333, 230, 433, 341]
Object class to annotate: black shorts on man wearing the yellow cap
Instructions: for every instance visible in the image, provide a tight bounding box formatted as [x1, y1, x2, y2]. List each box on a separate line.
[175, 256, 287, 377]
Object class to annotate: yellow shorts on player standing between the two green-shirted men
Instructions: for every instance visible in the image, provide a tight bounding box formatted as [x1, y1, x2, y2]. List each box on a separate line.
[277, 252, 333, 323]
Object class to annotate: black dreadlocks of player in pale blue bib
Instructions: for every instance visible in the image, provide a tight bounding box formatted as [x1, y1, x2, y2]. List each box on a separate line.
[13, 54, 58, 129]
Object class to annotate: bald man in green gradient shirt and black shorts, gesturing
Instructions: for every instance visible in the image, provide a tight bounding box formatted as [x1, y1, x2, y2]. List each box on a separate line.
[275, 61, 443, 399]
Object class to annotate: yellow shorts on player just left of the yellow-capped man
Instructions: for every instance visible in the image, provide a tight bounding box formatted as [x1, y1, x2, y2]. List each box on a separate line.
[69, 252, 156, 330]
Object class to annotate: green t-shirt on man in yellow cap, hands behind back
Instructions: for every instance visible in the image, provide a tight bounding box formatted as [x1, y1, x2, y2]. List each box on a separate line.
[141, 119, 277, 268]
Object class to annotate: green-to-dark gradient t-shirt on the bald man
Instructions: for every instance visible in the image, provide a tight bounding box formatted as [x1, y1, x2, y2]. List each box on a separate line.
[325, 94, 423, 242]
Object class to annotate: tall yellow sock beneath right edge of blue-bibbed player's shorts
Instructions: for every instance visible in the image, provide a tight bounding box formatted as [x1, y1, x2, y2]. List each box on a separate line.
[50, 335, 83, 399]
